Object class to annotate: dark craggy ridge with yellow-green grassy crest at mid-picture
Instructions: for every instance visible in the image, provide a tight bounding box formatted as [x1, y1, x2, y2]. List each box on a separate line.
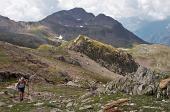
[68, 35, 138, 75]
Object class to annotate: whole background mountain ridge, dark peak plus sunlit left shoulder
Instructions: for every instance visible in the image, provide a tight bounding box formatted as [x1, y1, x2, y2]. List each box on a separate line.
[0, 8, 146, 48]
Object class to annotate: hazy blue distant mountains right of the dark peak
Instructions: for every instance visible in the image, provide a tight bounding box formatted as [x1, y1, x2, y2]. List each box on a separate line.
[122, 17, 170, 45]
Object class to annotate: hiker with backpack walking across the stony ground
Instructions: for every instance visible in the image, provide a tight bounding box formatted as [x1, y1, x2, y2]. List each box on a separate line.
[17, 77, 28, 101]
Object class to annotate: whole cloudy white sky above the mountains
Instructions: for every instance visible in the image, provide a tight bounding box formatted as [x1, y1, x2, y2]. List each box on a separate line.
[0, 0, 170, 21]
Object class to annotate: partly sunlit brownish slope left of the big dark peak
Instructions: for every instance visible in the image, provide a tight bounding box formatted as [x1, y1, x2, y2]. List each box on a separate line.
[0, 16, 60, 48]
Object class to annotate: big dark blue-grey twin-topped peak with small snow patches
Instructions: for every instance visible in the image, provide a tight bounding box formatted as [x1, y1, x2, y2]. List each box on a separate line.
[40, 8, 145, 47]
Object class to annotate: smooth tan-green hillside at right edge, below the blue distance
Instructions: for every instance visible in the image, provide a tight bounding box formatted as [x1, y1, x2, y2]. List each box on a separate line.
[129, 44, 170, 72]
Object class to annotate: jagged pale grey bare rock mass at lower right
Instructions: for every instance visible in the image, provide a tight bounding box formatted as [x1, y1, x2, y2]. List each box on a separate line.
[106, 67, 159, 95]
